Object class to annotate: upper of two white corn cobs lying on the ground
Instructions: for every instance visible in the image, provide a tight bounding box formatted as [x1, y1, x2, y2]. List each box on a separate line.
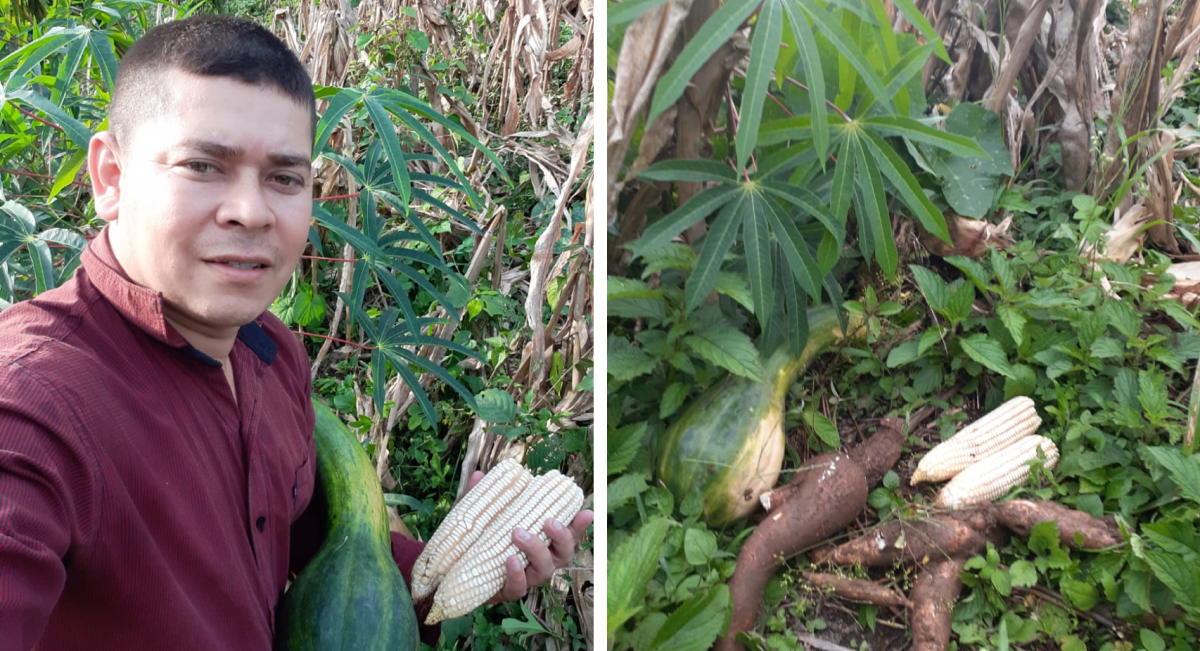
[912, 395, 1042, 485]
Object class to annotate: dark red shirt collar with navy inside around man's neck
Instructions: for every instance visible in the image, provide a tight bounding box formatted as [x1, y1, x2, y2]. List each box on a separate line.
[80, 226, 277, 366]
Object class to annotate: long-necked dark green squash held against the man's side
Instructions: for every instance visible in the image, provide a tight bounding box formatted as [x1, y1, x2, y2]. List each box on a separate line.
[275, 396, 420, 651]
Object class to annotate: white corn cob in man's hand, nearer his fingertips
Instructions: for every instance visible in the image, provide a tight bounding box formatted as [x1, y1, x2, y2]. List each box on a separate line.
[425, 471, 583, 623]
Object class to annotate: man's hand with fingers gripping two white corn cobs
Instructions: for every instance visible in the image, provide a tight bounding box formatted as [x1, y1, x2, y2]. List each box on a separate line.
[467, 471, 595, 603]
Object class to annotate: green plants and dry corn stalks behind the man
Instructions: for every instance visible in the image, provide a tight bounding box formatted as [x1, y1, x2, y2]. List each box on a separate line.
[0, 0, 594, 650]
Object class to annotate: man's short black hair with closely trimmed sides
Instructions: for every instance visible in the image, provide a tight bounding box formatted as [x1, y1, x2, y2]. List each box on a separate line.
[108, 16, 317, 154]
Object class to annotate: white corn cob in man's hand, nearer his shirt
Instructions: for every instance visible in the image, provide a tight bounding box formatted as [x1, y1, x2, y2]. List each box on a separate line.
[412, 459, 533, 601]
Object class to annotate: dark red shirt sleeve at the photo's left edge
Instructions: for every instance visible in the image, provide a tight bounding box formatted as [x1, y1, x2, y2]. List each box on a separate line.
[0, 365, 100, 651]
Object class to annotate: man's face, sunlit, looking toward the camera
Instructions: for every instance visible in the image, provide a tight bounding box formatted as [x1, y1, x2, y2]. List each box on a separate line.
[103, 71, 312, 333]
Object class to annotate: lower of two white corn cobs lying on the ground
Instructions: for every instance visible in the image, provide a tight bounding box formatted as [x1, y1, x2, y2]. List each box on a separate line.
[934, 436, 1058, 508]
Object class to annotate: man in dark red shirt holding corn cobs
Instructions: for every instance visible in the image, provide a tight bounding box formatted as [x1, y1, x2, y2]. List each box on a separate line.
[0, 12, 593, 651]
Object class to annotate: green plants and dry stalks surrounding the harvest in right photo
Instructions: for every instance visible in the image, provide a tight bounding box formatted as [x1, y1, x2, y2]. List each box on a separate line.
[606, 0, 1200, 651]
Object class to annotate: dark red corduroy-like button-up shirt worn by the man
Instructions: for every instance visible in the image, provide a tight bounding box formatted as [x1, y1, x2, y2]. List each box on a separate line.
[0, 228, 438, 651]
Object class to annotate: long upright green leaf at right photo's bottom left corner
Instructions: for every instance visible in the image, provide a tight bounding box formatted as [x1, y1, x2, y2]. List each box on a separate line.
[605, 518, 668, 639]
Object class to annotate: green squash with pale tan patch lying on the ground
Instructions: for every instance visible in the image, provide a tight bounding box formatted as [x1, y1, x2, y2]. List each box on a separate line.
[658, 306, 862, 527]
